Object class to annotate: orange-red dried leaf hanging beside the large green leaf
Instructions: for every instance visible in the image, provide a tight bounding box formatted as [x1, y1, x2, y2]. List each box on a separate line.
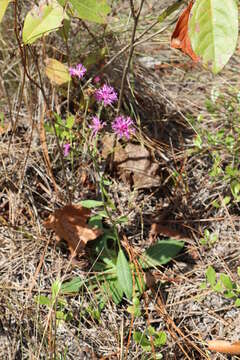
[171, 1, 199, 62]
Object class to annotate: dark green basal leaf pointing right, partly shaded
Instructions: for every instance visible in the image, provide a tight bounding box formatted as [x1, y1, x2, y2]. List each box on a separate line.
[140, 239, 184, 269]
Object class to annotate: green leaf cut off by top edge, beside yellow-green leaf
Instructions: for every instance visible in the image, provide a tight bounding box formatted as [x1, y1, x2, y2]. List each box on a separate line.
[69, 0, 111, 24]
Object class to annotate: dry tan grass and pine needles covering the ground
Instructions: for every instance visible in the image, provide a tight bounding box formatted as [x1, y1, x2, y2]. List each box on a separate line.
[0, 1, 240, 360]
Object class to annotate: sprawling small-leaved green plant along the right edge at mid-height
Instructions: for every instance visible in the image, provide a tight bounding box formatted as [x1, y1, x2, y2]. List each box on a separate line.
[190, 89, 240, 208]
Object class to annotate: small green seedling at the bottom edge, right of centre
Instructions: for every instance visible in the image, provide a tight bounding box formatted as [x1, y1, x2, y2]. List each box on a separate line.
[133, 326, 167, 359]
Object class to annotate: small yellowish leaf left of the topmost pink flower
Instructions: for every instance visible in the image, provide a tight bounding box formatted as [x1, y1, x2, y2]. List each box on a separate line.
[45, 58, 71, 85]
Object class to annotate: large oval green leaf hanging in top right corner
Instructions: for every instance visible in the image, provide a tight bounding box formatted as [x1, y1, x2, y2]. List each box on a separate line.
[189, 0, 238, 74]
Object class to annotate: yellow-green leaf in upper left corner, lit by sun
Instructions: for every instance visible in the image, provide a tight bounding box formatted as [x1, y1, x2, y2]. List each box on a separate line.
[22, 0, 68, 44]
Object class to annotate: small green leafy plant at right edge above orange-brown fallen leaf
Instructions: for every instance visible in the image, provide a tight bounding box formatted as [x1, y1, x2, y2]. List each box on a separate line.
[201, 266, 240, 307]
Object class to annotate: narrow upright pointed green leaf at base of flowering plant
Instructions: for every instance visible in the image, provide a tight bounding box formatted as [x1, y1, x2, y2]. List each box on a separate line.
[117, 249, 133, 299]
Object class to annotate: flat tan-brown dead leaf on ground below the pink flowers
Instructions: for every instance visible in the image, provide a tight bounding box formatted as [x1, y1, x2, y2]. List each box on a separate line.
[102, 135, 161, 189]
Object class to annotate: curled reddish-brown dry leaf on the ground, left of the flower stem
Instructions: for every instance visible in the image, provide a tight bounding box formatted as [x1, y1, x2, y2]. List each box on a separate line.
[44, 204, 102, 257]
